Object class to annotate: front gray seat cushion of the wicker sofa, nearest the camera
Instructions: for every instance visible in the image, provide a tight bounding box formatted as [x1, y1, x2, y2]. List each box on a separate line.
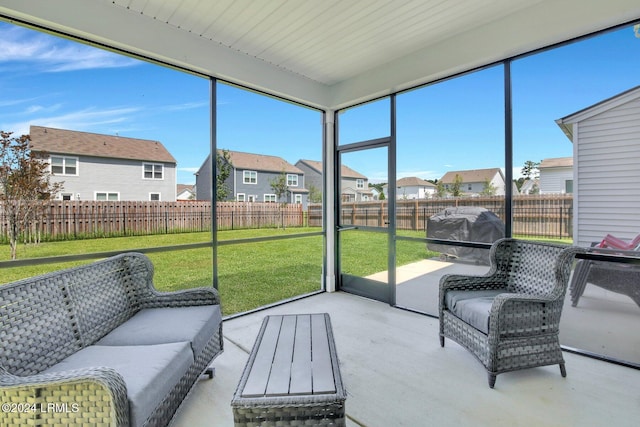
[44, 342, 194, 426]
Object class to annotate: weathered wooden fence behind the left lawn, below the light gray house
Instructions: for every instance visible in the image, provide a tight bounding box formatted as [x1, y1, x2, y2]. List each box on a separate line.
[0, 200, 304, 241]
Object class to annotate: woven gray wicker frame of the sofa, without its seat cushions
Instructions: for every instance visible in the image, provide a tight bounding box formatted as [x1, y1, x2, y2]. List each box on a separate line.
[0, 253, 223, 426]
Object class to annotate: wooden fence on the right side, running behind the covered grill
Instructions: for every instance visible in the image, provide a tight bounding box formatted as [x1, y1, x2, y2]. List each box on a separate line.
[309, 194, 573, 238]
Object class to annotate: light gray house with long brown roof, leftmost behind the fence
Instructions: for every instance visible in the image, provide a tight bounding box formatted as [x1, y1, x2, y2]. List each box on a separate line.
[30, 126, 177, 201]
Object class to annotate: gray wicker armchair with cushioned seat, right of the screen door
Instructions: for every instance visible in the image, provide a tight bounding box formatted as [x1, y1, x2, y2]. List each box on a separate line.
[439, 238, 583, 388]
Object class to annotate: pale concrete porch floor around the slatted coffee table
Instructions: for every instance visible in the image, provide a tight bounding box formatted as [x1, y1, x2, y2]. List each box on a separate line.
[173, 292, 640, 427]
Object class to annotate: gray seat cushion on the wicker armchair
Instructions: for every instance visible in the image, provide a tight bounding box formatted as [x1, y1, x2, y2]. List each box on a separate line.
[445, 289, 507, 334]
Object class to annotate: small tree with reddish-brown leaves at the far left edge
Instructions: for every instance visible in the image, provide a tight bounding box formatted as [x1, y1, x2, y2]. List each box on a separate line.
[0, 131, 63, 259]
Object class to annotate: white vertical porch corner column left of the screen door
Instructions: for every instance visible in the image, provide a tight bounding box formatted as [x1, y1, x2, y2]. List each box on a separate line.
[323, 110, 336, 292]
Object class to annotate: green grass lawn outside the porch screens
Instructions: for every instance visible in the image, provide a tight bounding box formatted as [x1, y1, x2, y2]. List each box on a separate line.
[0, 228, 568, 315]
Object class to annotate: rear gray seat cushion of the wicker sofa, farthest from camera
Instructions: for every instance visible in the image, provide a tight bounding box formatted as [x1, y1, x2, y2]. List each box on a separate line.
[96, 305, 222, 356]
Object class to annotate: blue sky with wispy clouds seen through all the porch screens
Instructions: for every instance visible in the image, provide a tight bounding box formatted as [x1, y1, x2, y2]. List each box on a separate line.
[0, 22, 640, 183]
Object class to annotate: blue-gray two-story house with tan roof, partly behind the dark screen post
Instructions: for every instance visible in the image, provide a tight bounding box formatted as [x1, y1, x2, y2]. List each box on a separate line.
[196, 150, 309, 209]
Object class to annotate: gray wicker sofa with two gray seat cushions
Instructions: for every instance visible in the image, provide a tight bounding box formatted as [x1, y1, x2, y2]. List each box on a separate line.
[0, 253, 222, 426]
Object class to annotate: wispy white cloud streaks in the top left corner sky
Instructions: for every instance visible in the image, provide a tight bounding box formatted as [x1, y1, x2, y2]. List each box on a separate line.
[0, 24, 139, 72]
